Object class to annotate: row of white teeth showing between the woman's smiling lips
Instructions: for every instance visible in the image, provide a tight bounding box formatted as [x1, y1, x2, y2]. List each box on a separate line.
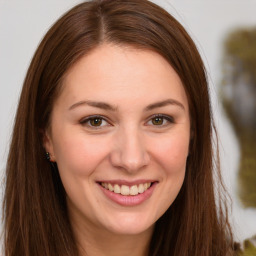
[100, 182, 153, 196]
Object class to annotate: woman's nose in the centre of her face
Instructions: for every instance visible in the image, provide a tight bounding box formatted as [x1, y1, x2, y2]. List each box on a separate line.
[110, 128, 150, 173]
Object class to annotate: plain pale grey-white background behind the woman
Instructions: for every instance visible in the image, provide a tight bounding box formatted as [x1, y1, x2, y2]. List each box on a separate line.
[0, 0, 256, 240]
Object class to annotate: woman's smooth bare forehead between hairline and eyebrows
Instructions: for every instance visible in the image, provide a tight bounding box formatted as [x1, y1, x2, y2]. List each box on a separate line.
[56, 44, 187, 111]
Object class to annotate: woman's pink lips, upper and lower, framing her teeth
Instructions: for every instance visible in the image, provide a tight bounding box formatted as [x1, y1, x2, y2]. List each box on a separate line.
[97, 180, 158, 206]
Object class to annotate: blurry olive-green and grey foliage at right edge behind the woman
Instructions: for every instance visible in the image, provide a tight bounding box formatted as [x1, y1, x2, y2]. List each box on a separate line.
[222, 28, 256, 208]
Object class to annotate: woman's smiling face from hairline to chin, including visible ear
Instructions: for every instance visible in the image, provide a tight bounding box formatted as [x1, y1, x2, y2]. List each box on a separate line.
[44, 44, 190, 237]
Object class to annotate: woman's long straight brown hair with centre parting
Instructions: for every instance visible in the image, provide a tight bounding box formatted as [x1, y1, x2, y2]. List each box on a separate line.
[4, 0, 232, 256]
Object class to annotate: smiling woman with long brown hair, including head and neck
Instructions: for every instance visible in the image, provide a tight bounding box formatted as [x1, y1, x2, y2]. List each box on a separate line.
[4, 0, 232, 256]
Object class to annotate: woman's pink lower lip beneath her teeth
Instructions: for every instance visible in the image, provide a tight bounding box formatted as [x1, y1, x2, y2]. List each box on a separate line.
[99, 182, 156, 206]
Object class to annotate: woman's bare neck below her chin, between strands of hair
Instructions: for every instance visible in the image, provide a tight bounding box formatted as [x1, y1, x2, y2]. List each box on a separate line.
[72, 216, 154, 256]
